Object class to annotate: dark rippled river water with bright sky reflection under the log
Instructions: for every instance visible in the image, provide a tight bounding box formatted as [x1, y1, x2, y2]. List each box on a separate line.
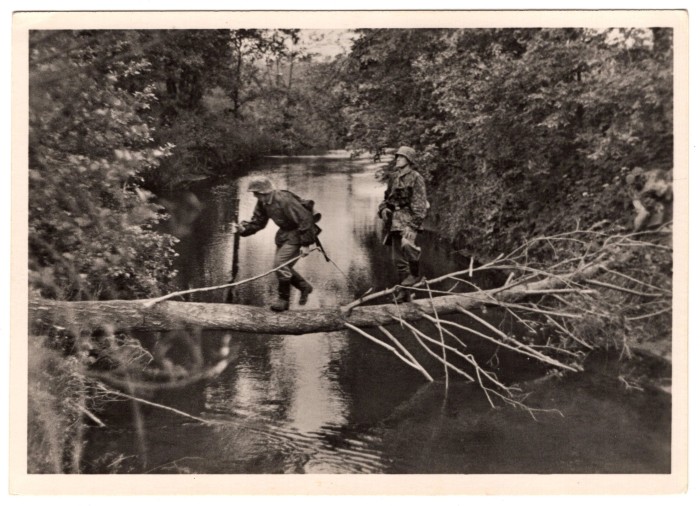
[85, 153, 671, 474]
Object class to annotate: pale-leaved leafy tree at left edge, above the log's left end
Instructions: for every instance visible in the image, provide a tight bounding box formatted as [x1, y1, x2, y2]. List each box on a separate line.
[29, 31, 174, 299]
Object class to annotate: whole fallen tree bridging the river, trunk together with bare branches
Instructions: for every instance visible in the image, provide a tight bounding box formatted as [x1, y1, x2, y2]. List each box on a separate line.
[29, 230, 671, 417]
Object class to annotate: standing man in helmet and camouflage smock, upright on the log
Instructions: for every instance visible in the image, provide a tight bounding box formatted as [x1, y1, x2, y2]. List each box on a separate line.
[379, 146, 428, 302]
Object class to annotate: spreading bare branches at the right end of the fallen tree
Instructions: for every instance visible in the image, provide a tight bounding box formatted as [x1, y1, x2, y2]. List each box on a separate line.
[343, 228, 672, 417]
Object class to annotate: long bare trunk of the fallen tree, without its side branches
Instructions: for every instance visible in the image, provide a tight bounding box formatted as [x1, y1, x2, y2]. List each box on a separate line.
[29, 261, 611, 334]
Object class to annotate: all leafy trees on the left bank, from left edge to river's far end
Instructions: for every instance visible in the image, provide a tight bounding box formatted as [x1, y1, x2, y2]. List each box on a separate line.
[29, 29, 348, 299]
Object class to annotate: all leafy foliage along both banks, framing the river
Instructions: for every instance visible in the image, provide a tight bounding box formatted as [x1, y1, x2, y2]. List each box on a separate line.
[28, 29, 673, 472]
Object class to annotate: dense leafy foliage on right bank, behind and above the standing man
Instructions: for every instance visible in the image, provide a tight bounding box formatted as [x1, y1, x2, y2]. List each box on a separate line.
[345, 29, 673, 254]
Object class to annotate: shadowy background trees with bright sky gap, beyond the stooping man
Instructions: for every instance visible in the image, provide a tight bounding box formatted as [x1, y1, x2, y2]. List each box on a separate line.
[138, 29, 344, 188]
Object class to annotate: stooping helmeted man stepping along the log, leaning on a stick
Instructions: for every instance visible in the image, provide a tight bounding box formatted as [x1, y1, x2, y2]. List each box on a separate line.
[236, 177, 319, 311]
